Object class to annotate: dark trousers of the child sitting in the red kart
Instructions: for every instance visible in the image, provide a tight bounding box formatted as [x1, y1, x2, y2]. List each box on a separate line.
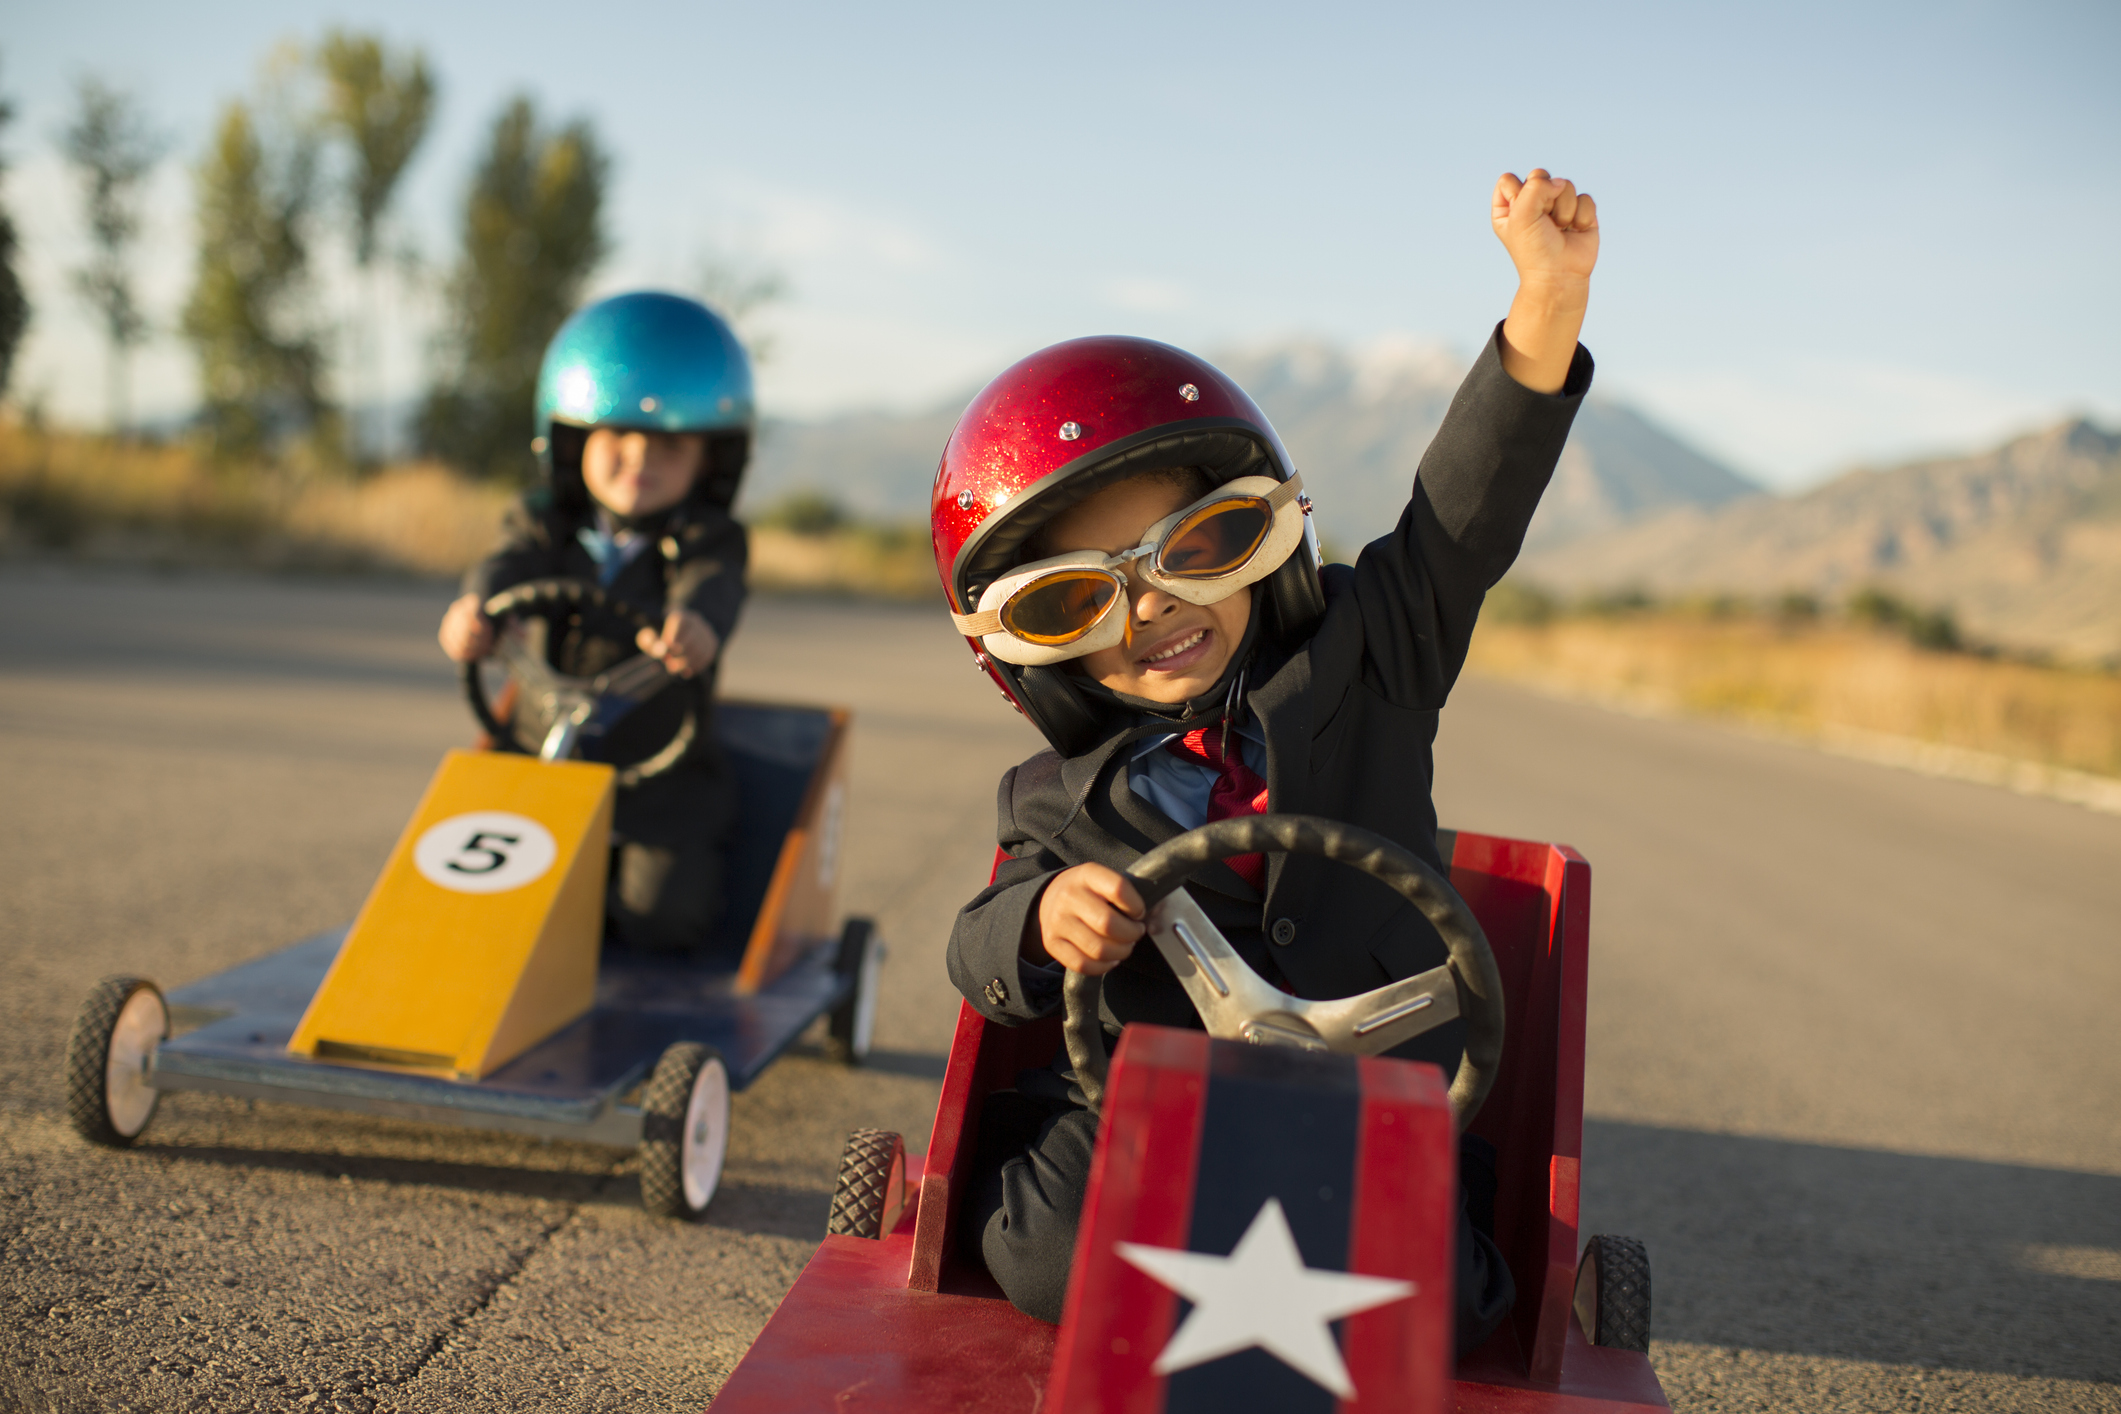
[959, 1077, 1517, 1355]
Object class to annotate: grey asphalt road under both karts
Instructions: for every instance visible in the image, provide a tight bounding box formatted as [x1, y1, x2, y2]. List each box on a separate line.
[0, 568, 2121, 1412]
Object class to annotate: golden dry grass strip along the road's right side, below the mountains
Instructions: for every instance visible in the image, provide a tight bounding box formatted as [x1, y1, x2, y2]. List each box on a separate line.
[1468, 613, 2121, 776]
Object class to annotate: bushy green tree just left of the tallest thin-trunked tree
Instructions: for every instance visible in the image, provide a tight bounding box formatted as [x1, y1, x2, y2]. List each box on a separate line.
[185, 102, 331, 458]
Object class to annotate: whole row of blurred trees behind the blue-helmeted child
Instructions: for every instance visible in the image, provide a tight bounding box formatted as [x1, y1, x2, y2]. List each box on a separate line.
[0, 30, 644, 483]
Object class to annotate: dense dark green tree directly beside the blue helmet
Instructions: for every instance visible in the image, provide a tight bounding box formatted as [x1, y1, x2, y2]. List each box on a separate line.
[420, 95, 611, 477]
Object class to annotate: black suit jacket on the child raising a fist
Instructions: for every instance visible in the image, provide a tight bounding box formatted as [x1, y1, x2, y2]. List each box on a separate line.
[950, 329, 1593, 1071]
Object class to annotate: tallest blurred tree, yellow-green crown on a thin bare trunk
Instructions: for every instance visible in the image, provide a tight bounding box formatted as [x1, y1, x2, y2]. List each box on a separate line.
[316, 30, 435, 462]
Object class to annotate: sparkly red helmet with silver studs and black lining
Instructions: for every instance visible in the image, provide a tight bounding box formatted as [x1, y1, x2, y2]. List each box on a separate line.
[929, 335, 1326, 755]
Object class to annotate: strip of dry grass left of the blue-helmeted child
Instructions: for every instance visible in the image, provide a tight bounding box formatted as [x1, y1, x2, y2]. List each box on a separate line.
[0, 424, 509, 575]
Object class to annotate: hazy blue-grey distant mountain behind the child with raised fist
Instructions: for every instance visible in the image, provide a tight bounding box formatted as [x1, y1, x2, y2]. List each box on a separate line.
[747, 341, 1760, 558]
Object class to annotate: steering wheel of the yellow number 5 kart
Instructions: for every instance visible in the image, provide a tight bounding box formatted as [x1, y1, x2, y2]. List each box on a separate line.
[464, 579, 700, 786]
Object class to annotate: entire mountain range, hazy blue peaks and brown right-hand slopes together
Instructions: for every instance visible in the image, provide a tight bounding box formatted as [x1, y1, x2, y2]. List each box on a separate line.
[747, 341, 2121, 664]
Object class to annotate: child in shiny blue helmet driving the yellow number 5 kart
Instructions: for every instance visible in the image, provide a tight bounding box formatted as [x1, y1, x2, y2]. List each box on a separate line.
[439, 293, 753, 952]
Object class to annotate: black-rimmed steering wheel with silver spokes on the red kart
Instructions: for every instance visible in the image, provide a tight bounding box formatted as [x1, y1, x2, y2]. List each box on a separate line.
[1061, 814, 1502, 1132]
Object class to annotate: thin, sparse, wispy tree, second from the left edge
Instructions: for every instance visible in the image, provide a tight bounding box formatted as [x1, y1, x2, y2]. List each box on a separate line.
[59, 78, 163, 435]
